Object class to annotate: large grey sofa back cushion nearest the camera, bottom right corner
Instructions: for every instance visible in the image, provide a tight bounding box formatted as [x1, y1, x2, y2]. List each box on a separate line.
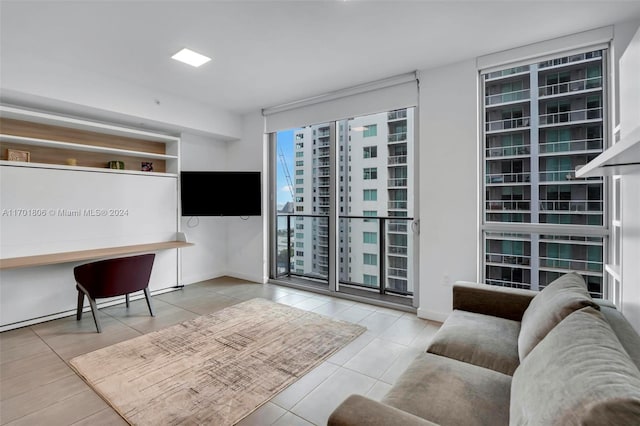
[510, 307, 640, 426]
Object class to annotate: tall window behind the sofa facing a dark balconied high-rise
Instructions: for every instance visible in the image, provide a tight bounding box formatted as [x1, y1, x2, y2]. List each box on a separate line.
[481, 48, 608, 297]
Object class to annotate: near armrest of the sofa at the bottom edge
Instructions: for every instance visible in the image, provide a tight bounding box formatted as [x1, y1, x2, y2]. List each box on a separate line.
[327, 395, 437, 426]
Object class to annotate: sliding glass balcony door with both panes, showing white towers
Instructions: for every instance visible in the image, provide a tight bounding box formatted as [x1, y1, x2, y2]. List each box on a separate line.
[272, 108, 417, 302]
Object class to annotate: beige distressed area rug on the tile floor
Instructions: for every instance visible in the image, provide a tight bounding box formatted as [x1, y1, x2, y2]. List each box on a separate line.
[71, 299, 366, 425]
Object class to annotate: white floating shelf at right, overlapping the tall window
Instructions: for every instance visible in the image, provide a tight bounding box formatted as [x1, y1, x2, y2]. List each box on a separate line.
[576, 126, 640, 178]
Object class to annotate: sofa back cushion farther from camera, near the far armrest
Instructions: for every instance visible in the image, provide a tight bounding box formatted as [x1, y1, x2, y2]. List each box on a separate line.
[518, 272, 598, 362]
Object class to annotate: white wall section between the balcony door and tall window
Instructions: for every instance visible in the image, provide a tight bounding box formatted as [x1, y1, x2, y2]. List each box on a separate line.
[418, 60, 479, 320]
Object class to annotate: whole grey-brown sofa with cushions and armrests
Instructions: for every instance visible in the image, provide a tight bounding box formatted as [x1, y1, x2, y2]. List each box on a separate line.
[328, 273, 640, 426]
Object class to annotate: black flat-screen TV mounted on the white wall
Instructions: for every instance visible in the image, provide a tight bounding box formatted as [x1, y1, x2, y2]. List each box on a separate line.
[180, 171, 262, 216]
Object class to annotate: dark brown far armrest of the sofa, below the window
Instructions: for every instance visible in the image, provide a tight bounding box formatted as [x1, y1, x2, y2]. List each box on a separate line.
[453, 281, 538, 321]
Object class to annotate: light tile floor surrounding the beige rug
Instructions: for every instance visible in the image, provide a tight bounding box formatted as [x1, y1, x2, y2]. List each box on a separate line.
[0, 277, 440, 426]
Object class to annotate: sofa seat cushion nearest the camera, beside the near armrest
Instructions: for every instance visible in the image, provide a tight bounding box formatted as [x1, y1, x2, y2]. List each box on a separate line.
[381, 353, 511, 426]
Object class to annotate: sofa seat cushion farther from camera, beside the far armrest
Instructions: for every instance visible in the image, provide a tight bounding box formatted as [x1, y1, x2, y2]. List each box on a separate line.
[427, 310, 520, 375]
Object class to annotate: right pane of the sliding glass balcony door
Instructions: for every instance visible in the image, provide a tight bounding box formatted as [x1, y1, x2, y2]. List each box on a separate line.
[337, 108, 414, 296]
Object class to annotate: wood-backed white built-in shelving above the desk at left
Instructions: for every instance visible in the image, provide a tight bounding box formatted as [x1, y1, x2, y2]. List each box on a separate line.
[0, 105, 180, 177]
